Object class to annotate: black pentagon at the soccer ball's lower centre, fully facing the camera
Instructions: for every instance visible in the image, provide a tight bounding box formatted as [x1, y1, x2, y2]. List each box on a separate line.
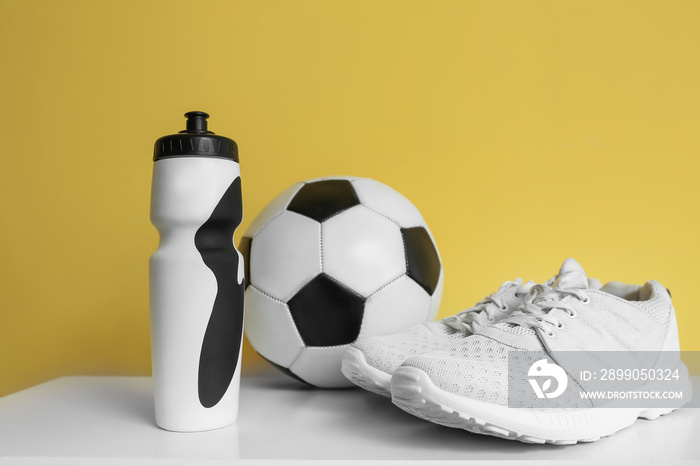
[287, 273, 365, 346]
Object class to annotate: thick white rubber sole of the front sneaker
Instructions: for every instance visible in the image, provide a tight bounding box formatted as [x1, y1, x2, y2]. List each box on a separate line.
[391, 367, 678, 445]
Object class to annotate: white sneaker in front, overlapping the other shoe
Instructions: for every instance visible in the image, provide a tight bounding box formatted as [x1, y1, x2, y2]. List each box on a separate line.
[391, 259, 692, 445]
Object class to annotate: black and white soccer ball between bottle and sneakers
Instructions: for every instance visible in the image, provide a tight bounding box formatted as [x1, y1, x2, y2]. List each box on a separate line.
[239, 177, 443, 388]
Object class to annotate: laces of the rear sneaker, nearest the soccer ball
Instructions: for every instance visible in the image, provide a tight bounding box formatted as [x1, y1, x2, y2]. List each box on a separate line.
[441, 278, 528, 333]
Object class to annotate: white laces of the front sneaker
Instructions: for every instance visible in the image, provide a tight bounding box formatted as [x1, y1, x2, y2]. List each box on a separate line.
[517, 285, 589, 337]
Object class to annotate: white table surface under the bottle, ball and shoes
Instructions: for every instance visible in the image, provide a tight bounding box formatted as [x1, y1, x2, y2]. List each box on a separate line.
[0, 373, 700, 466]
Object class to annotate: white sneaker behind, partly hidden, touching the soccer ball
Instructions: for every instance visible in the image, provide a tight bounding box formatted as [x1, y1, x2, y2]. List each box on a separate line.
[341, 278, 535, 397]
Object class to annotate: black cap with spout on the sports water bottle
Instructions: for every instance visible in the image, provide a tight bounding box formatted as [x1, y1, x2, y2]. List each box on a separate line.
[153, 112, 238, 162]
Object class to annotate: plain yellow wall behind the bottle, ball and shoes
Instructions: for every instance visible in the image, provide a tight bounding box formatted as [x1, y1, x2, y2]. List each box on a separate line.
[0, 0, 700, 395]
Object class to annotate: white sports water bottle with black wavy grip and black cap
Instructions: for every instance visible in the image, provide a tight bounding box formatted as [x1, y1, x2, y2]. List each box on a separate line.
[149, 112, 244, 432]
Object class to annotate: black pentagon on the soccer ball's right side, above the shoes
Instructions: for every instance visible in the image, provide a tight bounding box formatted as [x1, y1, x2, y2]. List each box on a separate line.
[401, 227, 441, 296]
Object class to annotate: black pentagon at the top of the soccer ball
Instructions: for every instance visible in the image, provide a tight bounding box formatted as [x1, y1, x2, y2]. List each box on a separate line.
[287, 180, 360, 222]
